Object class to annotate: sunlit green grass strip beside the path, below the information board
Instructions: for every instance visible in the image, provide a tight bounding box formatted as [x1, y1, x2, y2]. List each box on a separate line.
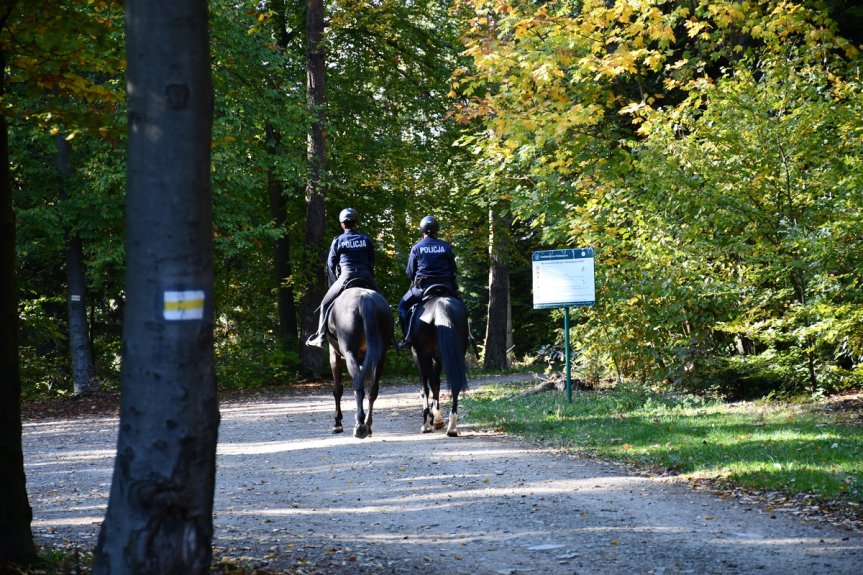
[464, 385, 863, 513]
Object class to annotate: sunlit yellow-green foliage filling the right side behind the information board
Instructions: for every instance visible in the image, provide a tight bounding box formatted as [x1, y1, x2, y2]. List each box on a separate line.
[453, 0, 863, 393]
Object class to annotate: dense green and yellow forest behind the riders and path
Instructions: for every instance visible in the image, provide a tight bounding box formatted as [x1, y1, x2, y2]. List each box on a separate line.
[0, 0, 863, 396]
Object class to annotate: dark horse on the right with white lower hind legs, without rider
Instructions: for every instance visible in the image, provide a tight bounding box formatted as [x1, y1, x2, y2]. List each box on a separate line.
[410, 286, 470, 437]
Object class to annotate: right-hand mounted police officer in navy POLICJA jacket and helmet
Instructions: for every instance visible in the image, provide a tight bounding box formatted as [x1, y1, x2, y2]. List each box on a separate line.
[398, 216, 458, 350]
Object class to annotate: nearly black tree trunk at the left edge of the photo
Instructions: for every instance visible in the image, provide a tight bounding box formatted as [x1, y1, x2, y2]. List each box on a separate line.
[0, 45, 36, 564]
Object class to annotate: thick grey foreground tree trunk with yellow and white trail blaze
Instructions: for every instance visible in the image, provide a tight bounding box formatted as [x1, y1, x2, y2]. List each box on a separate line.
[93, 0, 219, 575]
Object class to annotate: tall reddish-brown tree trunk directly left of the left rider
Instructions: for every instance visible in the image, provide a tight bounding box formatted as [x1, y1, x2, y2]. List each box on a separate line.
[301, 0, 327, 373]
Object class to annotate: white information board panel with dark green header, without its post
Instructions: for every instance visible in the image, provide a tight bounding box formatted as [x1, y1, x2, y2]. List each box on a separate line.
[533, 248, 596, 309]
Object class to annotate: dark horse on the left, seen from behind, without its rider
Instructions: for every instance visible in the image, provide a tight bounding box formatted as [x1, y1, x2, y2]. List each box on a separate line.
[327, 287, 393, 439]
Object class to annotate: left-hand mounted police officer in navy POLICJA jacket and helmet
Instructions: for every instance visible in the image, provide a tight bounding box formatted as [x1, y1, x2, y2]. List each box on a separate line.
[306, 208, 378, 347]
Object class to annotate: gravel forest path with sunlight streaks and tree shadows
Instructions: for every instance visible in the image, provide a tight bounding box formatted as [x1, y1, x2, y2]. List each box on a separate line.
[24, 376, 863, 575]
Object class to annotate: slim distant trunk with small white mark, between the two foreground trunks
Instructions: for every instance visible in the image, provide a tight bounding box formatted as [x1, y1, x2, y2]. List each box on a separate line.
[56, 133, 97, 395]
